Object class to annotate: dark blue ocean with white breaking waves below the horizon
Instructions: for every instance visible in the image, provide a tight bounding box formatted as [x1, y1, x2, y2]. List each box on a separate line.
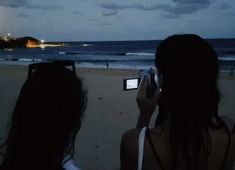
[0, 39, 235, 70]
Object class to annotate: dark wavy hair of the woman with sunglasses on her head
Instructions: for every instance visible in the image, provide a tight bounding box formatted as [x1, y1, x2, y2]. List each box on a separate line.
[0, 61, 86, 170]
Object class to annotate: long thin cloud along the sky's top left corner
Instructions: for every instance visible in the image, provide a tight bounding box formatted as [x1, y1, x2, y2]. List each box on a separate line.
[0, 0, 62, 10]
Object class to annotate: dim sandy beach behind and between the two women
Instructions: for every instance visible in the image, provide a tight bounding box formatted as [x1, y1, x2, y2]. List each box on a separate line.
[0, 64, 235, 170]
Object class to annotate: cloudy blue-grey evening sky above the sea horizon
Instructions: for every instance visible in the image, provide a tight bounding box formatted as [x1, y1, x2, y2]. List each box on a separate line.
[0, 0, 235, 41]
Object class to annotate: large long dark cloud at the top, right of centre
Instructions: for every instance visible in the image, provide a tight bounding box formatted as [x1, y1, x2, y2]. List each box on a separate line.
[100, 0, 211, 17]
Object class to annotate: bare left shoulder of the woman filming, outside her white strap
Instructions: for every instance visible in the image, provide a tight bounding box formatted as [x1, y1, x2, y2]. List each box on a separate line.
[120, 129, 140, 170]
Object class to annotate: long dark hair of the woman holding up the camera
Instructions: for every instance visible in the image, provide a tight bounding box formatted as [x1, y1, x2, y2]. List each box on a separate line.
[155, 34, 230, 170]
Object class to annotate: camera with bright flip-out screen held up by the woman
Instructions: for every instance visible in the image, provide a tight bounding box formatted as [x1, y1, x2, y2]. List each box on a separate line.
[123, 67, 158, 98]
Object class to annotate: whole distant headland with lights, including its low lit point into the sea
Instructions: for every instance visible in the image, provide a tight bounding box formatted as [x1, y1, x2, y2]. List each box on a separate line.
[0, 34, 65, 49]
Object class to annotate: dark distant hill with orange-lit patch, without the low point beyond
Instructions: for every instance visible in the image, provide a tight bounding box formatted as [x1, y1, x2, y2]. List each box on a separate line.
[0, 36, 40, 48]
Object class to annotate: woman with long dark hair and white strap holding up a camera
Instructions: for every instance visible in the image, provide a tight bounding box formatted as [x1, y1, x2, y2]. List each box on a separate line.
[121, 34, 235, 170]
